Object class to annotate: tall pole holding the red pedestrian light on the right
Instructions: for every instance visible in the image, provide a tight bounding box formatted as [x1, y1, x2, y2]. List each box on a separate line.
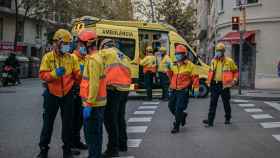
[238, 4, 246, 95]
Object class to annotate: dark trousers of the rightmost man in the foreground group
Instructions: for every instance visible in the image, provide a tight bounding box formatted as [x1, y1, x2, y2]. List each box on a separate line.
[104, 90, 128, 151]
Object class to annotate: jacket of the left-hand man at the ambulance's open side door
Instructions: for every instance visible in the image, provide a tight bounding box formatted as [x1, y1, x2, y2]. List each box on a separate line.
[140, 55, 157, 74]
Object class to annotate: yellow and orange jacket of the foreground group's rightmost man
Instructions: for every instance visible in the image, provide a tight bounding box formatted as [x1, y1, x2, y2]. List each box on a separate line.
[100, 48, 131, 91]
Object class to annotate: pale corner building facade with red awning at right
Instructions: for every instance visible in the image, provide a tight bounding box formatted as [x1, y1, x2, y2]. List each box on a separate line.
[197, 0, 280, 88]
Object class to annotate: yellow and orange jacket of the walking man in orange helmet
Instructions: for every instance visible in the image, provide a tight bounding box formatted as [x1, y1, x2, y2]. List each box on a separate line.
[169, 60, 199, 91]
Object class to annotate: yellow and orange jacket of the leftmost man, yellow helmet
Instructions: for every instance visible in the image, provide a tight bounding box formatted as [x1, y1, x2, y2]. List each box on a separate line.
[39, 51, 79, 97]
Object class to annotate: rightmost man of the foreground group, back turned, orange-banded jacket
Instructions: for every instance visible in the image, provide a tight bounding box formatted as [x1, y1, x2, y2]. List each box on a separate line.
[100, 39, 131, 158]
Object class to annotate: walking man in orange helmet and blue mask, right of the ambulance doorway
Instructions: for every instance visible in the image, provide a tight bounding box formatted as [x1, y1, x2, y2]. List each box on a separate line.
[168, 45, 199, 134]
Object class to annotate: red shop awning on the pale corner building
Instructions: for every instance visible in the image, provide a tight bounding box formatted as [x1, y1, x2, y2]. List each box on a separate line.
[220, 31, 255, 44]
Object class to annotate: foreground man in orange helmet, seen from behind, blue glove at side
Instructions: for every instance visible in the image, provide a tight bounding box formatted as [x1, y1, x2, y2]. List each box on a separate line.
[79, 30, 106, 158]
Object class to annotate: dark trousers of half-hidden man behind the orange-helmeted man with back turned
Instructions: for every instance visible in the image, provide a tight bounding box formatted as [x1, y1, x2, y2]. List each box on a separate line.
[72, 88, 83, 144]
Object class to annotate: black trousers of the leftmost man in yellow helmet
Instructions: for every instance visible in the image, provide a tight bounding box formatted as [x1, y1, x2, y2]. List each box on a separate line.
[39, 90, 74, 150]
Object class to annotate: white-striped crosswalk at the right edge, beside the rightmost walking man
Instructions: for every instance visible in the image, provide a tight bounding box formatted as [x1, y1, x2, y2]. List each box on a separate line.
[232, 99, 280, 142]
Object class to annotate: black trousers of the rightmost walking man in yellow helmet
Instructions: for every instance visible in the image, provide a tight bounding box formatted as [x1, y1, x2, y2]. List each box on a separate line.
[208, 82, 231, 124]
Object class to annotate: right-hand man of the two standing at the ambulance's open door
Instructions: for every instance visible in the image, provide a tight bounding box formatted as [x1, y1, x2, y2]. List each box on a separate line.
[157, 47, 171, 101]
